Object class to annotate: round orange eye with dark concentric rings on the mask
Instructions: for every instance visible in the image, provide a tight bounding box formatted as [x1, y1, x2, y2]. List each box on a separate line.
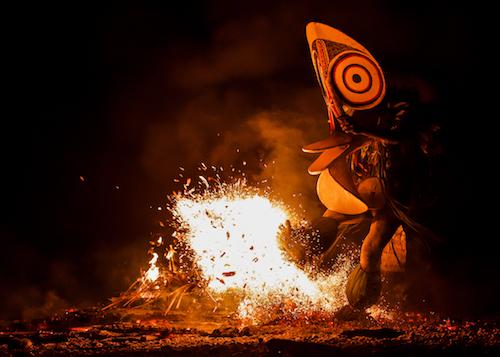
[331, 52, 385, 109]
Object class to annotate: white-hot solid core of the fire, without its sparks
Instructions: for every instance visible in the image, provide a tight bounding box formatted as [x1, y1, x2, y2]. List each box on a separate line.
[176, 196, 316, 294]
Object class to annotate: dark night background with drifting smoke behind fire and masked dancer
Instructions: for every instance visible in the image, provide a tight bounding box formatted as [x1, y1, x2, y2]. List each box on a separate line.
[0, 1, 498, 319]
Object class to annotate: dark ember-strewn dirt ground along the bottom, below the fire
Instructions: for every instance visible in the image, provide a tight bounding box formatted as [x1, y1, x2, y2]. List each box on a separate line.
[0, 309, 500, 356]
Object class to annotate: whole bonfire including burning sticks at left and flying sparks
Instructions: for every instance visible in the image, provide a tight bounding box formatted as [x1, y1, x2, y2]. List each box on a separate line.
[105, 165, 352, 324]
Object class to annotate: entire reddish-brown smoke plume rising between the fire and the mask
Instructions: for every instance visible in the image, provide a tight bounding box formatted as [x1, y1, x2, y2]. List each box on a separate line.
[131, 6, 338, 220]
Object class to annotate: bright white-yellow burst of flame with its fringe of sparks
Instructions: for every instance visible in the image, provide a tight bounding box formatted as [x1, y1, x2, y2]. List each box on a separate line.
[169, 180, 349, 320]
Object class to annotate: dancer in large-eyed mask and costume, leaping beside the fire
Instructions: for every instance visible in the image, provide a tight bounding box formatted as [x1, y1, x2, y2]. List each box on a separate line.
[285, 22, 440, 308]
